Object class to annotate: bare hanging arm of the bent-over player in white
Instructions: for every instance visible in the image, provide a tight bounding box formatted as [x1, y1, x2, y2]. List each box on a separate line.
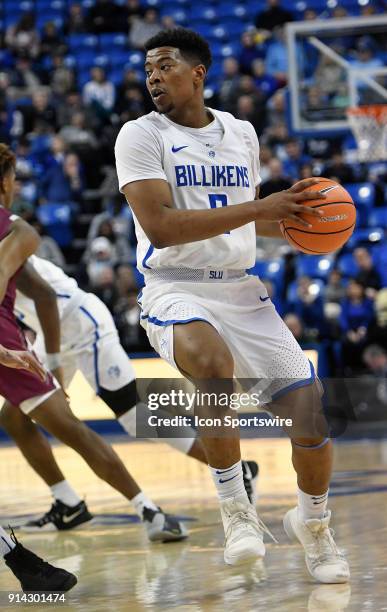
[16, 261, 60, 354]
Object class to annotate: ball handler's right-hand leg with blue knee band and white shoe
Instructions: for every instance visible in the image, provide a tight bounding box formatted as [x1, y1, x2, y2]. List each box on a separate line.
[274, 383, 350, 583]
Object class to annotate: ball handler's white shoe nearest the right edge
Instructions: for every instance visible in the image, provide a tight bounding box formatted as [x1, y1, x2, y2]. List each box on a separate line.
[284, 508, 350, 584]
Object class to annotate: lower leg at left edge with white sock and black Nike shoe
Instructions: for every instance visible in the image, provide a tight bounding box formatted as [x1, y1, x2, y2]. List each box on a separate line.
[0, 402, 93, 531]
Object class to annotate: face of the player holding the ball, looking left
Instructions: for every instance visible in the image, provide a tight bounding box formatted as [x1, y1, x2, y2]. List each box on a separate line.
[145, 47, 205, 114]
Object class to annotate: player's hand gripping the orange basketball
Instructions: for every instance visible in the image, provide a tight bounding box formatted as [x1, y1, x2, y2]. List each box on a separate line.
[256, 179, 326, 227]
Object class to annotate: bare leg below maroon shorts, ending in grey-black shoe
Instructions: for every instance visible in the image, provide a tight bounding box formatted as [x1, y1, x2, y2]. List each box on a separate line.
[26, 390, 186, 541]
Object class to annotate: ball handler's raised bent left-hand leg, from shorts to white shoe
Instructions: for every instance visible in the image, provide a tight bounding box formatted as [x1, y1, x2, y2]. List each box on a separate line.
[174, 321, 265, 565]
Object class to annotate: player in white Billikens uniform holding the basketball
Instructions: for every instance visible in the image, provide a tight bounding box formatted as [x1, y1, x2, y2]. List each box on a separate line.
[115, 28, 349, 583]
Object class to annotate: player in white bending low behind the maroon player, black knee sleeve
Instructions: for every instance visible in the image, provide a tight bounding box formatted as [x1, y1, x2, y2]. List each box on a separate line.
[0, 255, 258, 531]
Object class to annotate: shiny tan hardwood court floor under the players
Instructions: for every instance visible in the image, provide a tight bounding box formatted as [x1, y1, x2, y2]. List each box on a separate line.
[0, 438, 387, 612]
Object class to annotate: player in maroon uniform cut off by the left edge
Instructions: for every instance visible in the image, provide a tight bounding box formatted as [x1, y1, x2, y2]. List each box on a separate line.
[0, 144, 187, 541]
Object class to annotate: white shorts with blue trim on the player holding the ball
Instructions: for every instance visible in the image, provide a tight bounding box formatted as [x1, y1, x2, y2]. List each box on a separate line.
[139, 271, 315, 403]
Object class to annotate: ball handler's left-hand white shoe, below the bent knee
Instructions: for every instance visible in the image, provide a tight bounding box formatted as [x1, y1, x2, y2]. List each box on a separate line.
[220, 495, 274, 565]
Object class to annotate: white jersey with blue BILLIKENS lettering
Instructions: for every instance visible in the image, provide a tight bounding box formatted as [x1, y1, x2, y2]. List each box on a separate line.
[115, 109, 260, 279]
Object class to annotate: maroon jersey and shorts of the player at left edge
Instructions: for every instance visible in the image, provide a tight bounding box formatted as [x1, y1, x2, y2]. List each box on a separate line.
[0, 206, 56, 406]
